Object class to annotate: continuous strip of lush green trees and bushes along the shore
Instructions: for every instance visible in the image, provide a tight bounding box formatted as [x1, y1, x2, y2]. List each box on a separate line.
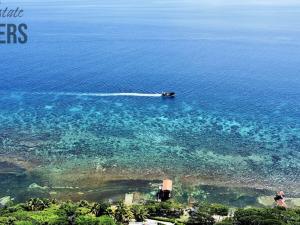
[0, 198, 300, 225]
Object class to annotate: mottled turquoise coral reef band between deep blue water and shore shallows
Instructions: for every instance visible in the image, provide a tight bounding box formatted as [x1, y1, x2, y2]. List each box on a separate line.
[0, 92, 300, 202]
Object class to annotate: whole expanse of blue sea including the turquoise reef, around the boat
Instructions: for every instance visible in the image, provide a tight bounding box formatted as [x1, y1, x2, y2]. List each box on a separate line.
[0, 0, 300, 204]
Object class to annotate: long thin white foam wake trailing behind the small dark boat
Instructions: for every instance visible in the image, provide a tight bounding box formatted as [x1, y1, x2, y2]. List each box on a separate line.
[34, 92, 161, 97]
